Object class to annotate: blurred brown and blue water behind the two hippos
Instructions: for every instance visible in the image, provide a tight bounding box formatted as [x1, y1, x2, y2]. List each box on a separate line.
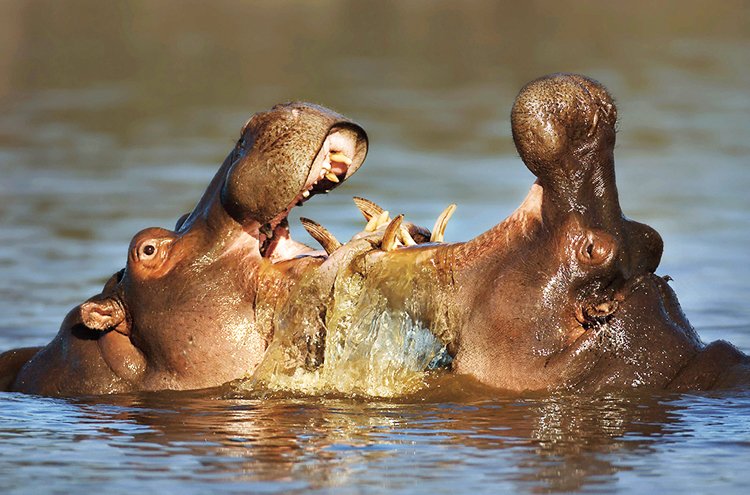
[0, 0, 750, 351]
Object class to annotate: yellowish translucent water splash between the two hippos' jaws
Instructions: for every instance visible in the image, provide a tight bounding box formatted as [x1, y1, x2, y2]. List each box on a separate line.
[247, 246, 450, 397]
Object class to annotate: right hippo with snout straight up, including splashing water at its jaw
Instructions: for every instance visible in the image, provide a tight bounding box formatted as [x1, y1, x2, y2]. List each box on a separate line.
[256, 74, 750, 395]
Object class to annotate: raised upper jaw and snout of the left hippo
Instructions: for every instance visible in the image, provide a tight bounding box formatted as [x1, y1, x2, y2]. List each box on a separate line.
[176, 102, 368, 262]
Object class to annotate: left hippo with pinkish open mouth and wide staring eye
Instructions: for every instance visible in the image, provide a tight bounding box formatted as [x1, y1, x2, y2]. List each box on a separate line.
[0, 103, 367, 395]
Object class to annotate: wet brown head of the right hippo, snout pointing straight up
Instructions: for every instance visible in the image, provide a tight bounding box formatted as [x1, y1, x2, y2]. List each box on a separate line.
[451, 74, 741, 390]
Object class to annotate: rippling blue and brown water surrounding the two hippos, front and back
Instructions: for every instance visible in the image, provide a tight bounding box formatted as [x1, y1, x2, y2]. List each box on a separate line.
[0, 0, 750, 493]
